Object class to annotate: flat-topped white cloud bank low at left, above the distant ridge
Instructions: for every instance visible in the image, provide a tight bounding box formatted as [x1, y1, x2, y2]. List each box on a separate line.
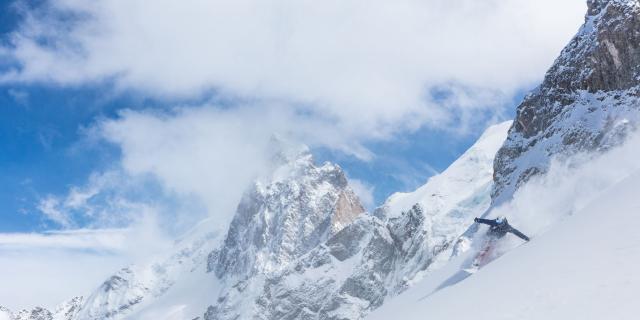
[0, 223, 170, 311]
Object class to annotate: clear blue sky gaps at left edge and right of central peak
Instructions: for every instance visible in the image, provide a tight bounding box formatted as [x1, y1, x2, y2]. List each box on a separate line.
[0, 79, 517, 232]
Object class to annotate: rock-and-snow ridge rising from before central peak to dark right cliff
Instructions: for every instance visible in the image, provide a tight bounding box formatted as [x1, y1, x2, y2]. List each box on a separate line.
[205, 122, 510, 320]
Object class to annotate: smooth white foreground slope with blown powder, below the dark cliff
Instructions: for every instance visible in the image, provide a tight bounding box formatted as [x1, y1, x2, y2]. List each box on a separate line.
[367, 131, 640, 320]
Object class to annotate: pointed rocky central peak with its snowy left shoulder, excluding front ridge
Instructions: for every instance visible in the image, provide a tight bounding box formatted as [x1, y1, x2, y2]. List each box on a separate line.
[36, 139, 364, 319]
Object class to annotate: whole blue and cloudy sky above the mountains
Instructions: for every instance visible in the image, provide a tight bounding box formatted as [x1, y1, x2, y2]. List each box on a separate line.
[0, 0, 586, 308]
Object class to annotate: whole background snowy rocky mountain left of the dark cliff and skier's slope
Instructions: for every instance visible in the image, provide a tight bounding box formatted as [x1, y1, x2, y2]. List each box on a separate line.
[0, 122, 510, 320]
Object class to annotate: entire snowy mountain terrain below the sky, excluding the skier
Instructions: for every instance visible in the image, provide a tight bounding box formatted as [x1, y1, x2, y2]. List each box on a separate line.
[5, 0, 640, 320]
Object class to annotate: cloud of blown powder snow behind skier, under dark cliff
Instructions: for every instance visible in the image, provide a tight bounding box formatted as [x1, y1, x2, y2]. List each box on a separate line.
[492, 133, 640, 240]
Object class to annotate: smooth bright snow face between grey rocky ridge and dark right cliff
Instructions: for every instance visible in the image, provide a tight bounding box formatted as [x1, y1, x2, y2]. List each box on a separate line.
[376, 121, 511, 270]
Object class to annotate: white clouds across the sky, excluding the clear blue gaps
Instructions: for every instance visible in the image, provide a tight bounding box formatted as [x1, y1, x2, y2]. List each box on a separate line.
[0, 0, 585, 305]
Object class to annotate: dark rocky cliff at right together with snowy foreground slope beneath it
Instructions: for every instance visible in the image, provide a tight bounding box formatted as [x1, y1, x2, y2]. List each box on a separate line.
[368, 0, 640, 320]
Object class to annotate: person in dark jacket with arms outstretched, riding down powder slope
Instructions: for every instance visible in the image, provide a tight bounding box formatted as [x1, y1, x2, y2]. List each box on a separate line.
[467, 216, 529, 273]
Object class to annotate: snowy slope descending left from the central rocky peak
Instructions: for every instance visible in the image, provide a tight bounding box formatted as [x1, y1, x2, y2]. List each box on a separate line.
[75, 219, 221, 320]
